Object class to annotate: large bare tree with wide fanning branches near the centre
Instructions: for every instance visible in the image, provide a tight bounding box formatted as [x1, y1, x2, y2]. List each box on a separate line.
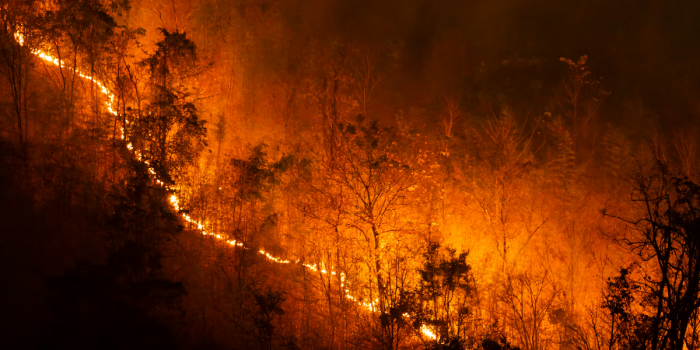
[300, 115, 431, 349]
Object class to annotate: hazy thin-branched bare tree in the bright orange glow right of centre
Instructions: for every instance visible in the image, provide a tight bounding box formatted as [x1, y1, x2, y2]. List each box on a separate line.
[466, 108, 548, 274]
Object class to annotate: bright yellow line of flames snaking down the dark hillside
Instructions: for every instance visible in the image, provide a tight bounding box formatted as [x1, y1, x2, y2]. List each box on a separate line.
[14, 32, 437, 339]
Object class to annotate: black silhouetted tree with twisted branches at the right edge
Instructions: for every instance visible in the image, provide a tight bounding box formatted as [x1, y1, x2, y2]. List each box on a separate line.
[603, 160, 700, 350]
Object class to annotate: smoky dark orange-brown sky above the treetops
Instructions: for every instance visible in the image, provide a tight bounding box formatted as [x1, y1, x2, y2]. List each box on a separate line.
[130, 0, 700, 134]
